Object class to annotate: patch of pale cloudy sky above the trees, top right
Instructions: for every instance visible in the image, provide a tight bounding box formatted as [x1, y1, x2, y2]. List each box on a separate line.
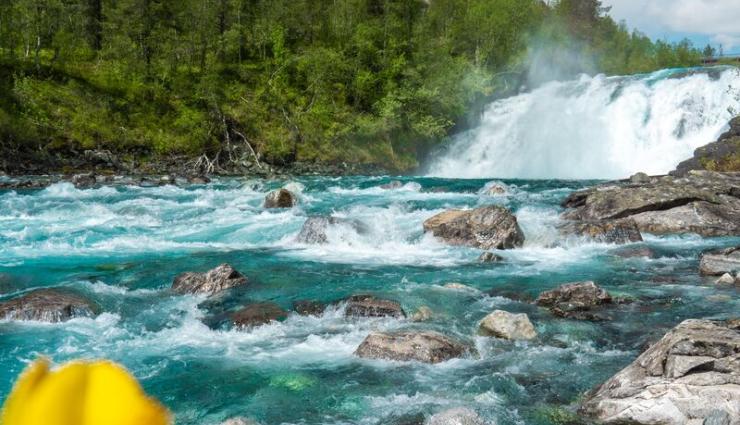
[602, 0, 740, 54]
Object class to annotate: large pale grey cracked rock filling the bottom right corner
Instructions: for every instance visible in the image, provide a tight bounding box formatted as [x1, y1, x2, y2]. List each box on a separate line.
[581, 320, 740, 425]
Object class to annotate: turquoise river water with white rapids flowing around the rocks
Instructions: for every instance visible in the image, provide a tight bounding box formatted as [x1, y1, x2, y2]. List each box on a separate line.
[0, 177, 740, 425]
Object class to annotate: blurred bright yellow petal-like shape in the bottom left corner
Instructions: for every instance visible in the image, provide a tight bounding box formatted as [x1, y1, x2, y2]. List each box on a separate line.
[0, 360, 171, 425]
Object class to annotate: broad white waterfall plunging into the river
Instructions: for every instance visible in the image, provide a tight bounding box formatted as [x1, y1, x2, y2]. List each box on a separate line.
[428, 67, 740, 179]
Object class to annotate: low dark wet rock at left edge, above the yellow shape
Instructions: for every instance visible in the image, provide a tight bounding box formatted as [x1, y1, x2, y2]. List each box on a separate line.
[0, 289, 98, 322]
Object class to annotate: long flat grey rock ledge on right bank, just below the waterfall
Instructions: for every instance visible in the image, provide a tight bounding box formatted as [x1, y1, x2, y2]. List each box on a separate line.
[562, 171, 740, 236]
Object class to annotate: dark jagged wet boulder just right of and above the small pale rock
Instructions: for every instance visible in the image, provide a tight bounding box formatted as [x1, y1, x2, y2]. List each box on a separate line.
[535, 281, 613, 320]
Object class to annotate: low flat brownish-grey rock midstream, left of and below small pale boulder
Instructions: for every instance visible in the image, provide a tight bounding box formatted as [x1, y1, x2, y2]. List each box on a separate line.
[355, 332, 467, 363]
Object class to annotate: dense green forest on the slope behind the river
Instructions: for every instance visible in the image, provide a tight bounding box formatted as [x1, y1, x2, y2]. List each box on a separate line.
[0, 0, 702, 171]
